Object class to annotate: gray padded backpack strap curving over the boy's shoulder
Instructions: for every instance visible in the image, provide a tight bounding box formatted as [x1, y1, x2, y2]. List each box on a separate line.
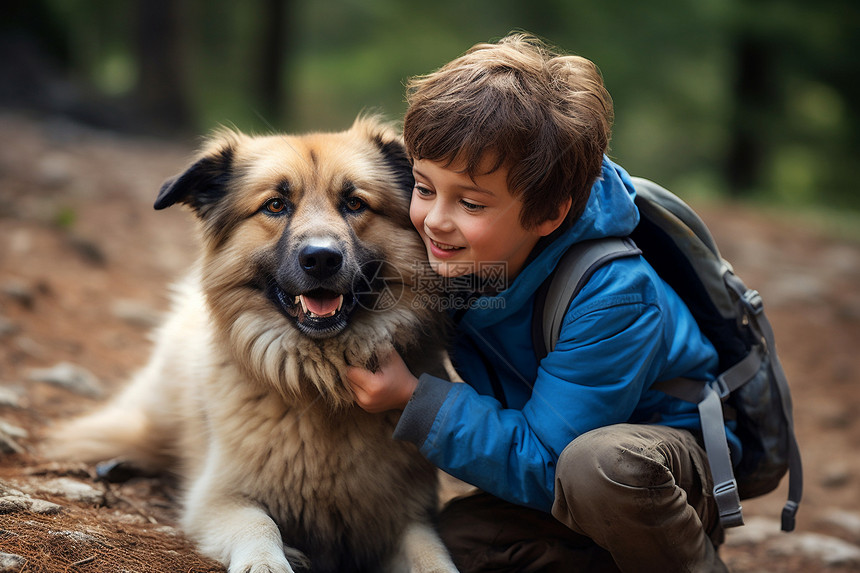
[535, 237, 642, 356]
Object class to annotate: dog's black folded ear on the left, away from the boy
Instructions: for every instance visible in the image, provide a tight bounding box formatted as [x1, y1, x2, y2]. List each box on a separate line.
[154, 142, 235, 216]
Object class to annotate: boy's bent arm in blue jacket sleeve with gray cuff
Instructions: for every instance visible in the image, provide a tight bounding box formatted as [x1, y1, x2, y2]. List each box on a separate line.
[395, 297, 662, 511]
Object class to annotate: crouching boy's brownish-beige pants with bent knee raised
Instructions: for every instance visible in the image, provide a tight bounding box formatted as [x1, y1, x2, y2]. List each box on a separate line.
[440, 424, 727, 573]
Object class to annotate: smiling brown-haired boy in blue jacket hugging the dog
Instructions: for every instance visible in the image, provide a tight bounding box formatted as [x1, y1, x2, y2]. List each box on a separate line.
[348, 34, 728, 571]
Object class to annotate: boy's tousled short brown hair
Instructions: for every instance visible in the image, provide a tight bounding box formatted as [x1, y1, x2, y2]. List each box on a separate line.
[403, 34, 612, 229]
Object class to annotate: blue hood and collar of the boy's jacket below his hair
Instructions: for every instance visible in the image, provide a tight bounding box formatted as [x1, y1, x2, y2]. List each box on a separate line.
[463, 156, 639, 327]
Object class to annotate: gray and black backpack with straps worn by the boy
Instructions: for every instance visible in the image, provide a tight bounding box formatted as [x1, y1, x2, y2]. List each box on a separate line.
[532, 177, 803, 531]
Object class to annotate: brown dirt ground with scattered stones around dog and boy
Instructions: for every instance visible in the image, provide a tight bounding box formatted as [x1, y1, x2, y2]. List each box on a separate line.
[0, 113, 860, 573]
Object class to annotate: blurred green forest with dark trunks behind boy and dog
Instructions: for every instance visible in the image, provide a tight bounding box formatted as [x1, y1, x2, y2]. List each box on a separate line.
[0, 0, 860, 210]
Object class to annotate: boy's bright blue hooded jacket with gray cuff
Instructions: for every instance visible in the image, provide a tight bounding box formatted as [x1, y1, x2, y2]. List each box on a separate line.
[395, 155, 740, 511]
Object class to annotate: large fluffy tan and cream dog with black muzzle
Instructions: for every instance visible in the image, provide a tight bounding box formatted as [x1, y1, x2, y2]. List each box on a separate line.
[48, 117, 456, 573]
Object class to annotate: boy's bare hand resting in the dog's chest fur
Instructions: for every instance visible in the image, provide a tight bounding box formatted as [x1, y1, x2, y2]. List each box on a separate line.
[346, 351, 418, 414]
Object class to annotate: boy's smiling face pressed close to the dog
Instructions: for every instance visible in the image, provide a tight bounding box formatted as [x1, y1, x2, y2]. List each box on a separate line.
[409, 159, 547, 284]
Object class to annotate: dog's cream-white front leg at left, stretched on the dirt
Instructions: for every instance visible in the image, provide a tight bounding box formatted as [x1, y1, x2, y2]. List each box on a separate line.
[182, 464, 304, 573]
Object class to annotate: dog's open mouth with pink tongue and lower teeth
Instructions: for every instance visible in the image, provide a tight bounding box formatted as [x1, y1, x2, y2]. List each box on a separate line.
[272, 285, 356, 338]
